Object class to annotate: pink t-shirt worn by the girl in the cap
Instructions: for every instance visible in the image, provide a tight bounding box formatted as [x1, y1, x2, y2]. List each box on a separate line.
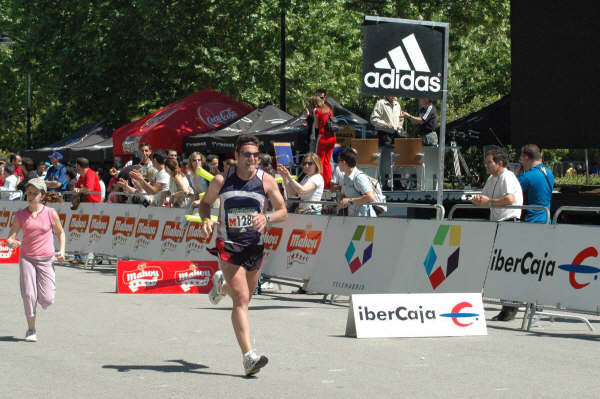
[15, 205, 56, 258]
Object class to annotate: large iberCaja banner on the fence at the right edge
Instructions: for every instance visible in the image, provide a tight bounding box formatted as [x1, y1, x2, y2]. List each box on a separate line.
[484, 223, 600, 312]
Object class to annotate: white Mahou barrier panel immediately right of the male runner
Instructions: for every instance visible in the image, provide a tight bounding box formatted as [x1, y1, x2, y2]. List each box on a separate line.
[262, 214, 329, 280]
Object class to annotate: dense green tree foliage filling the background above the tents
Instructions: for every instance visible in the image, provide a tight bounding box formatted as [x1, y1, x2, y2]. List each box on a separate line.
[0, 0, 510, 151]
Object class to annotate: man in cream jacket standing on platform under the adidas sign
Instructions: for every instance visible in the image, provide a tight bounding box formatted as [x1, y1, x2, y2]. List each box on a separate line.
[370, 96, 404, 191]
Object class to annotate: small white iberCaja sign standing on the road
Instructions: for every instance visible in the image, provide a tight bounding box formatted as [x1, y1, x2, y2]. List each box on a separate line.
[346, 293, 487, 338]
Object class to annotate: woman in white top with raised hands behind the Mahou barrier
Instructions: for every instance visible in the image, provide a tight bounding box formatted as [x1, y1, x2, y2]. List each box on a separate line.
[277, 152, 325, 215]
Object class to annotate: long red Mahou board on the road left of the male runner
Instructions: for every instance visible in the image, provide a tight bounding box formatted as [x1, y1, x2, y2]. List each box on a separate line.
[117, 260, 219, 294]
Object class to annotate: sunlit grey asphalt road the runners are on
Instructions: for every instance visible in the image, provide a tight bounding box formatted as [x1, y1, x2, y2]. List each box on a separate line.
[0, 265, 600, 399]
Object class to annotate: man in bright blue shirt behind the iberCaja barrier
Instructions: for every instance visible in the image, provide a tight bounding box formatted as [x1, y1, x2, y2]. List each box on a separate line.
[517, 144, 554, 223]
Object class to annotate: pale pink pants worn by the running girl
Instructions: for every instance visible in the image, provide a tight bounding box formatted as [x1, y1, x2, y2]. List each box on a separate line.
[19, 256, 56, 317]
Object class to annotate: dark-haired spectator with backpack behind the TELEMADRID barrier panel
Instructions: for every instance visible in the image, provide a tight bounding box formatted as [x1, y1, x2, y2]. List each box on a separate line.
[338, 147, 377, 217]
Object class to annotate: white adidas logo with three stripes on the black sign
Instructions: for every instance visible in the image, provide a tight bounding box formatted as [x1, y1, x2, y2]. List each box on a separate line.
[364, 33, 441, 92]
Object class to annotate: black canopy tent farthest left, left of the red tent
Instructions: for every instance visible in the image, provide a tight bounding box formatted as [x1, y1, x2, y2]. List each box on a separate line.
[23, 122, 112, 162]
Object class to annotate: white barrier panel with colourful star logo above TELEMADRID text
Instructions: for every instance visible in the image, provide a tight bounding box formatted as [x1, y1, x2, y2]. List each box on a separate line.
[307, 216, 415, 295]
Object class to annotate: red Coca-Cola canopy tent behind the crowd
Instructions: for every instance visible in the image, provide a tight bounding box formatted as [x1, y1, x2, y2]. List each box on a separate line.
[113, 89, 252, 157]
